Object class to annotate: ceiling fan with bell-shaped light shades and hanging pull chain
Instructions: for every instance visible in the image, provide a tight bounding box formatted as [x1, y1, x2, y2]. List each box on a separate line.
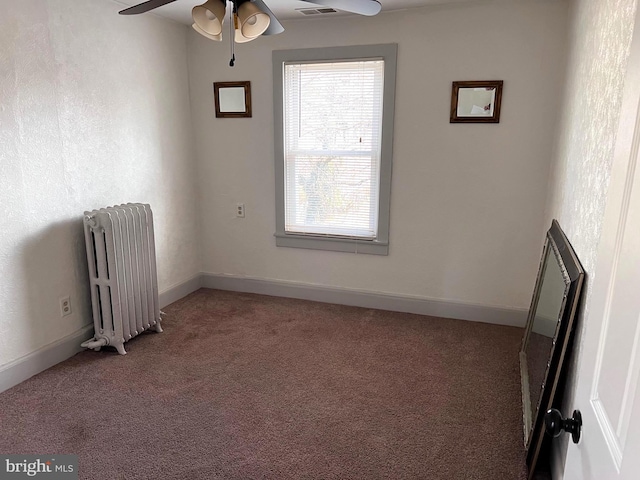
[119, 0, 382, 67]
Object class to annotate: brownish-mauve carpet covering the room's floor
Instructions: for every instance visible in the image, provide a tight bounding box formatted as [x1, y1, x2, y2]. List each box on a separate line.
[0, 289, 525, 480]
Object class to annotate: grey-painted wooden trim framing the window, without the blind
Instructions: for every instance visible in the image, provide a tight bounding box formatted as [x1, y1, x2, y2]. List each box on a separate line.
[272, 43, 398, 255]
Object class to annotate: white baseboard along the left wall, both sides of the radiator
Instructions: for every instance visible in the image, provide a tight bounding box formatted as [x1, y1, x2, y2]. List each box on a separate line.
[0, 274, 202, 392]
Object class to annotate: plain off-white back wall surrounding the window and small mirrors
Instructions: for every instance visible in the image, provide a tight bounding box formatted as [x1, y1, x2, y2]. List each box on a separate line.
[189, 1, 567, 308]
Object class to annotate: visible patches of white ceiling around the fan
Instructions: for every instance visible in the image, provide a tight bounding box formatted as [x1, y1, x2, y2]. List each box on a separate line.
[113, 0, 473, 25]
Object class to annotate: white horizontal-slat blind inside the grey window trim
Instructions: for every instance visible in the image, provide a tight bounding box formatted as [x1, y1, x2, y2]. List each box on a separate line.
[283, 59, 384, 240]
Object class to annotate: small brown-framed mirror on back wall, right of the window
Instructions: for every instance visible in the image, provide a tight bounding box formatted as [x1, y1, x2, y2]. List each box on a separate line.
[449, 80, 504, 123]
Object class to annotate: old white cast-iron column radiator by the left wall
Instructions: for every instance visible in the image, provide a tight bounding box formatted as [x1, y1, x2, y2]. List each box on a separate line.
[82, 203, 162, 355]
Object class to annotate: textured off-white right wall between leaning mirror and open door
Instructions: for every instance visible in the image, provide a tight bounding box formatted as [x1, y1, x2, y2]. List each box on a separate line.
[545, 0, 636, 478]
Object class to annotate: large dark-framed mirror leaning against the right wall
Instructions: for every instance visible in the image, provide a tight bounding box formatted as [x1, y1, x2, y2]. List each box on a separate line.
[520, 220, 584, 479]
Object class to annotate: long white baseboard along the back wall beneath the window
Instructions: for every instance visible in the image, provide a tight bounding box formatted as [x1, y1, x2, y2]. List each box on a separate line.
[202, 273, 528, 327]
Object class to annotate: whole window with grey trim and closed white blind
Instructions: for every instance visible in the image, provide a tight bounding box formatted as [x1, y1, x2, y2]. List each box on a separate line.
[273, 44, 397, 255]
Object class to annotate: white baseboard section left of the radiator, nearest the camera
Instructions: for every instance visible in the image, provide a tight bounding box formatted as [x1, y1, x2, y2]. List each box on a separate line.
[0, 324, 93, 392]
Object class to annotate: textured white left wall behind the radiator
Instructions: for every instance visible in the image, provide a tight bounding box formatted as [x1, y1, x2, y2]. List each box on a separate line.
[0, 0, 200, 367]
